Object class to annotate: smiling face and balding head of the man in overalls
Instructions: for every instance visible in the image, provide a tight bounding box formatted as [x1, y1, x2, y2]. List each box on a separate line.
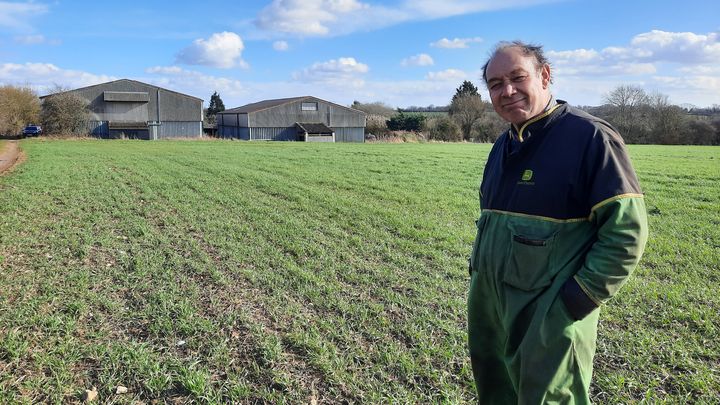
[486, 47, 550, 127]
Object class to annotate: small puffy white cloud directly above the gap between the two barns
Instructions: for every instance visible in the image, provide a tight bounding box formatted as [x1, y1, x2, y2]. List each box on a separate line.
[176, 31, 247, 69]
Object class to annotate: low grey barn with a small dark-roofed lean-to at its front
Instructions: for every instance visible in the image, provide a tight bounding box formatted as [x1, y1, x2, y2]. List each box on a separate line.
[216, 96, 365, 142]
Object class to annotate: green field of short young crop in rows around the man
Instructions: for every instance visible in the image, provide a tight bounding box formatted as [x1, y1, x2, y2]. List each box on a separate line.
[0, 139, 720, 404]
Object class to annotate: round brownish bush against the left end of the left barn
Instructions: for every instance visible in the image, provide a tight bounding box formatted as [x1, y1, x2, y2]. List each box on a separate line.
[40, 87, 89, 135]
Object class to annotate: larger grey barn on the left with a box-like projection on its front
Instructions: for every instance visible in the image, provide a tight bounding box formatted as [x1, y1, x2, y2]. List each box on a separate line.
[40, 79, 203, 139]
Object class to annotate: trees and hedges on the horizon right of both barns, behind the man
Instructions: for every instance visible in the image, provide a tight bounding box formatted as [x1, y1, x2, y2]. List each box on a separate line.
[351, 80, 720, 145]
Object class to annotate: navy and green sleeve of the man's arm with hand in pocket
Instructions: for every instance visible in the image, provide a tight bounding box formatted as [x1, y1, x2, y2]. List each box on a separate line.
[560, 120, 648, 320]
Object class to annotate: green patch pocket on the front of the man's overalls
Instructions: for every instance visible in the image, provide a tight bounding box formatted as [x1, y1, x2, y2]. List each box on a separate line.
[503, 224, 557, 291]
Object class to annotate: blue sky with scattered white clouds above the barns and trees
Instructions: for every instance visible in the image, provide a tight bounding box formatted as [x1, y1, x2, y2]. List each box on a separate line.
[0, 0, 720, 108]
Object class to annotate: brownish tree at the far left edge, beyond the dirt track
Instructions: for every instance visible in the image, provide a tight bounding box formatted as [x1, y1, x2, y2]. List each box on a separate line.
[0, 85, 40, 135]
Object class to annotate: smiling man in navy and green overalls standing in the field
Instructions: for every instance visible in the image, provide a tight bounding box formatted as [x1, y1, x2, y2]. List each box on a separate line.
[468, 41, 647, 404]
